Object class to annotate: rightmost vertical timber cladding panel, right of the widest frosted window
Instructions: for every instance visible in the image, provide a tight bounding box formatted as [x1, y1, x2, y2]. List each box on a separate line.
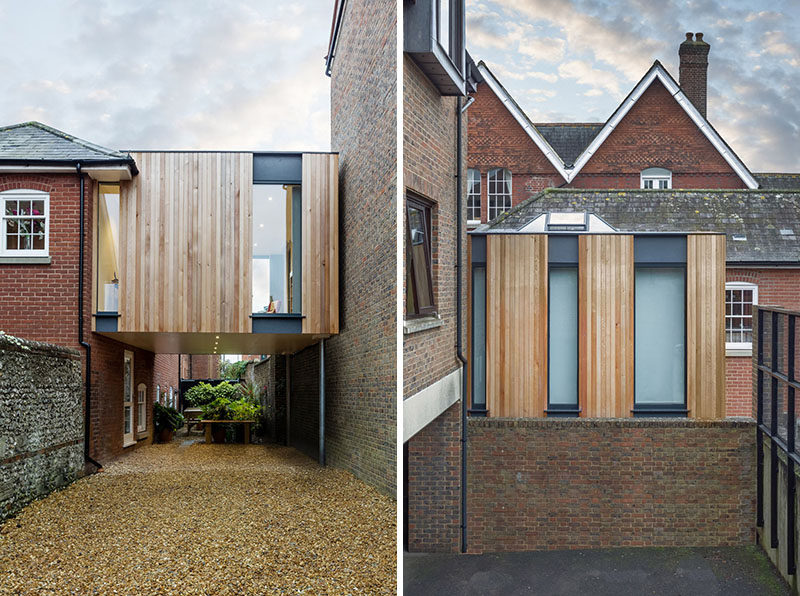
[686, 234, 725, 419]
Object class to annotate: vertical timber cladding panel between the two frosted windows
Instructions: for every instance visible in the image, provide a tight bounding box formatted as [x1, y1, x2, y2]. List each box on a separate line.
[578, 235, 634, 418]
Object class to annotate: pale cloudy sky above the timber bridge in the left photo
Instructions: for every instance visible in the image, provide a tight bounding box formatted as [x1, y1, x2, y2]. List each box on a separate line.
[0, 0, 333, 151]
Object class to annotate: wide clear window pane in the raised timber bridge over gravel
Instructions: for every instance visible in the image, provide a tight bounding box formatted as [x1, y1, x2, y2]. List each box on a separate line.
[252, 184, 292, 313]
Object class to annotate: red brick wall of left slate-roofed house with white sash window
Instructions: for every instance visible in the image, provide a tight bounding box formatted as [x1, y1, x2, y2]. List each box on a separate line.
[0, 174, 162, 463]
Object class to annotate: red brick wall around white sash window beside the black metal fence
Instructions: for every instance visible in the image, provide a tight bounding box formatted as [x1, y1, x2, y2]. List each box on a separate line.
[725, 268, 800, 416]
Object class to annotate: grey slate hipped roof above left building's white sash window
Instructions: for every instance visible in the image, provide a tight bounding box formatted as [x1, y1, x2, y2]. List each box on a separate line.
[0, 122, 133, 163]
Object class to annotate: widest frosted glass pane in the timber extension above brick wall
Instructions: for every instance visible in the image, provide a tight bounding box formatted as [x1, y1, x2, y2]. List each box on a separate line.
[634, 268, 686, 405]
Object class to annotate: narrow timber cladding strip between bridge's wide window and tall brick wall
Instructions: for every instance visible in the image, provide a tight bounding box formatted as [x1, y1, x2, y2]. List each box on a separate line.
[302, 153, 339, 335]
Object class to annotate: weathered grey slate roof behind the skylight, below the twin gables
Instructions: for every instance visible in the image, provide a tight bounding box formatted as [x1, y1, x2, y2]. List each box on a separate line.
[475, 189, 800, 265]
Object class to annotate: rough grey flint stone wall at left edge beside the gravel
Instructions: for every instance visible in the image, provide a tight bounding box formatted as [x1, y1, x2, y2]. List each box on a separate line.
[0, 333, 84, 521]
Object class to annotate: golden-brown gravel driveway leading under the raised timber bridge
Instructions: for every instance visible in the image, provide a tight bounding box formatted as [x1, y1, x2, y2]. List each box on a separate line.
[0, 442, 396, 595]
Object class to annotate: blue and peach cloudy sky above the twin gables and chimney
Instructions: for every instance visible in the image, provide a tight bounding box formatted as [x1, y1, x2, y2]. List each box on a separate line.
[467, 0, 800, 172]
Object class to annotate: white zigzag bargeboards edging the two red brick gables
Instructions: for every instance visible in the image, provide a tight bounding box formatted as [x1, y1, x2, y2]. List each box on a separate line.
[478, 60, 758, 189]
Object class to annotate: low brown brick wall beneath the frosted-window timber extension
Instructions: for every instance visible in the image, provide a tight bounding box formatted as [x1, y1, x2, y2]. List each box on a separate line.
[466, 419, 756, 553]
